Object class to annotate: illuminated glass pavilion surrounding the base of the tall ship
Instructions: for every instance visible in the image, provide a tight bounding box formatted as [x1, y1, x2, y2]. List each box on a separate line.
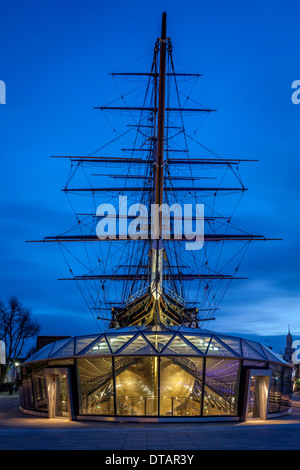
[21, 326, 292, 421]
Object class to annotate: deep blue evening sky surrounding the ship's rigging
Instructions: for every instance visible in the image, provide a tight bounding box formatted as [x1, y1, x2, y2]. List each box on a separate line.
[0, 0, 300, 352]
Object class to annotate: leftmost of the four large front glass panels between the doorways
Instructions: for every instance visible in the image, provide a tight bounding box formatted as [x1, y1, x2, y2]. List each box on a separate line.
[76, 357, 114, 415]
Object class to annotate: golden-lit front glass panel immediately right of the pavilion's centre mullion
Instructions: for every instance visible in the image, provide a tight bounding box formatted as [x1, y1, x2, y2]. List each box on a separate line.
[160, 357, 203, 416]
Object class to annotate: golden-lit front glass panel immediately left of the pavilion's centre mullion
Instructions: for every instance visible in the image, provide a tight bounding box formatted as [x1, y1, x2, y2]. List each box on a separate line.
[115, 356, 158, 416]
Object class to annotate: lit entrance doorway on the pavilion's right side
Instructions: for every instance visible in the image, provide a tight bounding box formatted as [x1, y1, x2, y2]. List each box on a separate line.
[244, 369, 272, 421]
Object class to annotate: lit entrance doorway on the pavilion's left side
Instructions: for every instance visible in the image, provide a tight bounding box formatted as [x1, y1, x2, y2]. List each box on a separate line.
[45, 368, 74, 420]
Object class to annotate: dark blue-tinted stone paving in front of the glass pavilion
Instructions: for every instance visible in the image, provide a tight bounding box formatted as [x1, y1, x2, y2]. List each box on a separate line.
[0, 395, 300, 451]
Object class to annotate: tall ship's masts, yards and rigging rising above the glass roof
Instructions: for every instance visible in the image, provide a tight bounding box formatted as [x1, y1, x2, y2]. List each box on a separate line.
[28, 13, 278, 327]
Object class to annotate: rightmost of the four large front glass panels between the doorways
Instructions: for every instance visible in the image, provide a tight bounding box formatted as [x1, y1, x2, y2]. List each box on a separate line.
[203, 358, 240, 416]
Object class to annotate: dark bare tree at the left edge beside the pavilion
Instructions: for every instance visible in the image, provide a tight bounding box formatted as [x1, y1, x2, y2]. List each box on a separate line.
[0, 297, 40, 382]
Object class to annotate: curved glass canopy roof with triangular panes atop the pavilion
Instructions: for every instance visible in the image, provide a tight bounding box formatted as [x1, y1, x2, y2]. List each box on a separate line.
[26, 327, 286, 364]
